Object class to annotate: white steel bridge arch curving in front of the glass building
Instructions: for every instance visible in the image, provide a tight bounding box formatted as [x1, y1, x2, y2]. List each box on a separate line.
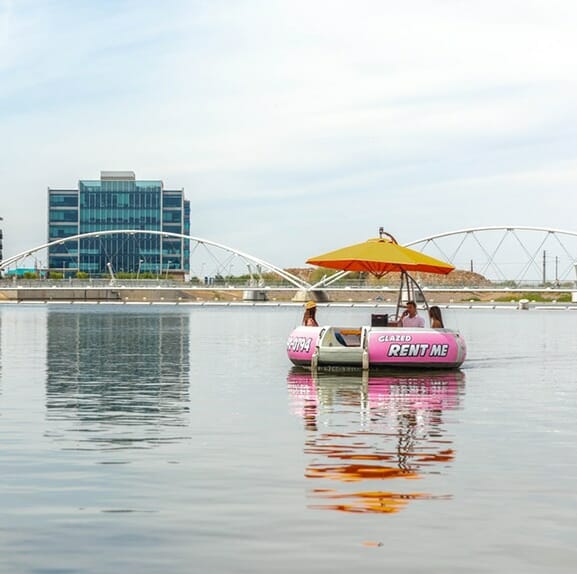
[0, 229, 310, 289]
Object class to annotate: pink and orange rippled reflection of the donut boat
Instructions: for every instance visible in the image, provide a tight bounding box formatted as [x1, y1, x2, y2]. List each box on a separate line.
[288, 370, 465, 514]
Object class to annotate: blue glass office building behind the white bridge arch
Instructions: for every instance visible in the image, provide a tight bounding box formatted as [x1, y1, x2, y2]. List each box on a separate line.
[48, 171, 190, 277]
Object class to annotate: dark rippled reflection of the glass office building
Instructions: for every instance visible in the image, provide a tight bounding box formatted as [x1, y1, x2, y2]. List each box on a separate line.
[46, 310, 189, 449]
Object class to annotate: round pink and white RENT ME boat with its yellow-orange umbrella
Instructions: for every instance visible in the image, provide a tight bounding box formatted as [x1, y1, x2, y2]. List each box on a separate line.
[287, 232, 467, 370]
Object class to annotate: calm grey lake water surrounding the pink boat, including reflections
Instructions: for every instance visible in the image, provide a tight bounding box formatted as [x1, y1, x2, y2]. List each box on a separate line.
[0, 304, 577, 574]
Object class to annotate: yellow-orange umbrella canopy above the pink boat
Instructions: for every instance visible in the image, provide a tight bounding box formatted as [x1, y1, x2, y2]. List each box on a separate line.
[307, 236, 455, 277]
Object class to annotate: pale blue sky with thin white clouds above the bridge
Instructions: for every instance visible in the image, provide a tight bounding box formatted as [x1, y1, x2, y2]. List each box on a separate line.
[0, 0, 577, 267]
